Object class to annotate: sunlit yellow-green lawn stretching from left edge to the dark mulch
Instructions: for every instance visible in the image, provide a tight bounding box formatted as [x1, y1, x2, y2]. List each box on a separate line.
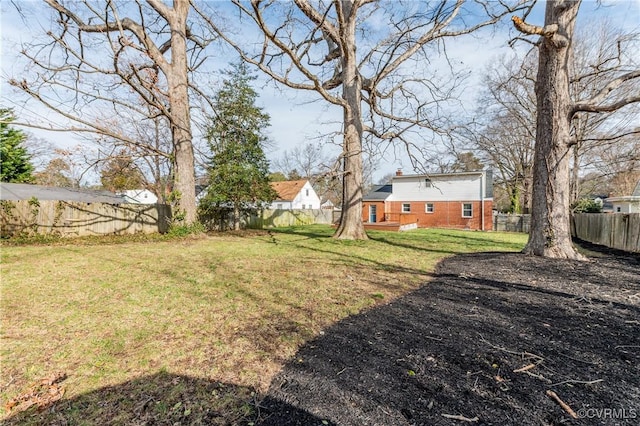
[0, 225, 526, 424]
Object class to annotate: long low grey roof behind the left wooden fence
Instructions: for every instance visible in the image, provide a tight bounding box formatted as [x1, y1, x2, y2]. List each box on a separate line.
[0, 182, 126, 204]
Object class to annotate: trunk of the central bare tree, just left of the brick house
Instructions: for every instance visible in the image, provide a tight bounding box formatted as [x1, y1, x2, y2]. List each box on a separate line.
[334, 1, 368, 240]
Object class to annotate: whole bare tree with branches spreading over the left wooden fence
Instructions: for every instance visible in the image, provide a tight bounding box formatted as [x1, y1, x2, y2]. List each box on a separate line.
[10, 0, 214, 224]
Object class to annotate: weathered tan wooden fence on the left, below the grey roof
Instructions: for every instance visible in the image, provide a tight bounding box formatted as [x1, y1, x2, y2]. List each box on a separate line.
[0, 199, 171, 238]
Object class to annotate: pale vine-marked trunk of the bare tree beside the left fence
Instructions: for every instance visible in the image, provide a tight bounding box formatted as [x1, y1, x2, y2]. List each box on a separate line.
[167, 0, 197, 225]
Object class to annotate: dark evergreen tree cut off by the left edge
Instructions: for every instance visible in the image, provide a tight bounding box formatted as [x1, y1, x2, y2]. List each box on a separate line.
[0, 108, 33, 183]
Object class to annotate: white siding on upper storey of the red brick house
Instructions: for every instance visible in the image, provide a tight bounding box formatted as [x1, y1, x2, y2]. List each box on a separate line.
[389, 174, 486, 201]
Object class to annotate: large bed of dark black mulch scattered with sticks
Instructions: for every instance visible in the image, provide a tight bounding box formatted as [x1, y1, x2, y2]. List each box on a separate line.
[256, 245, 640, 426]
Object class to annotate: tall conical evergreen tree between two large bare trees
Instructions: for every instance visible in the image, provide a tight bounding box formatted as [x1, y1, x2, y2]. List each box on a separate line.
[199, 63, 276, 229]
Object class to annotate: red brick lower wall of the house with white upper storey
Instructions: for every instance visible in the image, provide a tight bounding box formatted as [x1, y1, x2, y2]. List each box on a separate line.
[382, 200, 493, 231]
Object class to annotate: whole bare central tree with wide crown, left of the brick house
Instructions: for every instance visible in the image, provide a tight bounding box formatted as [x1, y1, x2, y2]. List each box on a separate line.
[199, 0, 527, 239]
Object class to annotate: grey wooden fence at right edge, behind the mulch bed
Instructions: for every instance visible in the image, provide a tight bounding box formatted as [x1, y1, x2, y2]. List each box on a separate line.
[573, 213, 640, 253]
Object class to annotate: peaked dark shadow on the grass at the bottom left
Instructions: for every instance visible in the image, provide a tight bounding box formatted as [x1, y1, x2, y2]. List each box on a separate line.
[2, 372, 330, 426]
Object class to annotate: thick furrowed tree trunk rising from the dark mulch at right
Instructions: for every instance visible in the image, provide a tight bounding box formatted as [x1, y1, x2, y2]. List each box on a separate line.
[524, 0, 583, 259]
